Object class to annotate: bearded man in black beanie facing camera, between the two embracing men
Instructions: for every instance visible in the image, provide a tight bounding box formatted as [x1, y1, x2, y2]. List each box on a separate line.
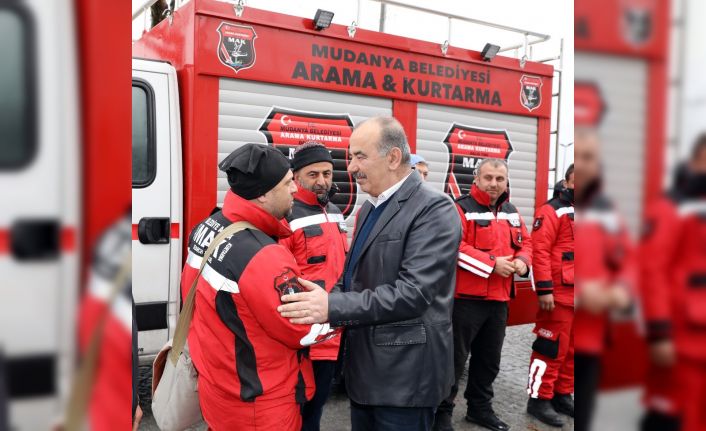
[280, 142, 348, 431]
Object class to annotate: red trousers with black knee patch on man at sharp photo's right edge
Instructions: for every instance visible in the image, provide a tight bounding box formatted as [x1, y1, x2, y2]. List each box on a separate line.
[527, 303, 574, 400]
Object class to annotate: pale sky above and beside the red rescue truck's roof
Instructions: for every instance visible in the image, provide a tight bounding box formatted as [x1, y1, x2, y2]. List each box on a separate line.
[132, 0, 574, 179]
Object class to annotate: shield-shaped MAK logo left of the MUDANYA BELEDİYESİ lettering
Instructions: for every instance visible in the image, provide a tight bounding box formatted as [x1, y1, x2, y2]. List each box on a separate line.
[218, 22, 257, 73]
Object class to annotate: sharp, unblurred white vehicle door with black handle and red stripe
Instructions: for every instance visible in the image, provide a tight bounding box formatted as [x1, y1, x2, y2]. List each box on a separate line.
[132, 60, 181, 360]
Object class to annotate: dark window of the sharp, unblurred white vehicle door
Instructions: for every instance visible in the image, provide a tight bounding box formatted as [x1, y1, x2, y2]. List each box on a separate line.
[132, 80, 157, 188]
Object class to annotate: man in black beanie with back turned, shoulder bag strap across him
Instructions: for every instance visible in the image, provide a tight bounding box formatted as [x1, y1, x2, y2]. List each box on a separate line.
[187, 144, 332, 431]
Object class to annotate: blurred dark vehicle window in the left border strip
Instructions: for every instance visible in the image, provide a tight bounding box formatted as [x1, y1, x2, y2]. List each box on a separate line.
[0, 2, 37, 170]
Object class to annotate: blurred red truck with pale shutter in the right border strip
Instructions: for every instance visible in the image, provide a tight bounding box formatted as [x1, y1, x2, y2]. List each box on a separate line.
[574, 0, 671, 388]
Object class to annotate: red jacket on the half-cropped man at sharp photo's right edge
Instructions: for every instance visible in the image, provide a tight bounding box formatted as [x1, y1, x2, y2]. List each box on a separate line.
[532, 190, 574, 307]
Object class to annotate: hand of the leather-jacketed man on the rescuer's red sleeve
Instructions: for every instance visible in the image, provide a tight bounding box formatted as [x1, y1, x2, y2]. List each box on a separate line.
[277, 278, 328, 325]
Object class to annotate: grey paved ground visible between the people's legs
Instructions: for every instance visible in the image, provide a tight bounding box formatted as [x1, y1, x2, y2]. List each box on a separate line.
[140, 325, 572, 431]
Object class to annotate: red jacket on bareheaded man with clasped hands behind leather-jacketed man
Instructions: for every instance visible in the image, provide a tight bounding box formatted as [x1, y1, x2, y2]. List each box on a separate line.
[455, 184, 532, 301]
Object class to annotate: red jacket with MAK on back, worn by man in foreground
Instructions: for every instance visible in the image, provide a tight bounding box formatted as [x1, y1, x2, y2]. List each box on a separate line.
[192, 191, 332, 420]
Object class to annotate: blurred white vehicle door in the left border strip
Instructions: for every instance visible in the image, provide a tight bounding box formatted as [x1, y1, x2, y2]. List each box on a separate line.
[0, 1, 80, 430]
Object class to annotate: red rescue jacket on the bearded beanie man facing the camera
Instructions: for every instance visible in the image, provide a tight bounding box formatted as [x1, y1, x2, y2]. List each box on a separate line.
[280, 186, 348, 361]
